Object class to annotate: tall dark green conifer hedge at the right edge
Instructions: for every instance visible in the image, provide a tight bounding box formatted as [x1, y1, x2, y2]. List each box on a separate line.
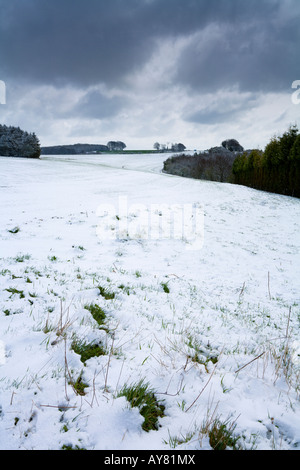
[232, 126, 300, 197]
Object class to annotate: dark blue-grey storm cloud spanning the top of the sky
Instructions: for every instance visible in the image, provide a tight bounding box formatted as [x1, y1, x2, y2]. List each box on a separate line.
[0, 0, 300, 91]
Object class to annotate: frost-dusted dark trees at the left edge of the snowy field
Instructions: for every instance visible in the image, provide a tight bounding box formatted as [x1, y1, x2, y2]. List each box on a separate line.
[0, 124, 41, 158]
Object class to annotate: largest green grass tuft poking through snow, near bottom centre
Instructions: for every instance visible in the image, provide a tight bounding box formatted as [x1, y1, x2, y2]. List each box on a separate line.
[118, 380, 165, 432]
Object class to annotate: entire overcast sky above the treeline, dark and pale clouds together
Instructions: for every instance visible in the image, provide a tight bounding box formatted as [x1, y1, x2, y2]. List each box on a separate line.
[0, 0, 300, 149]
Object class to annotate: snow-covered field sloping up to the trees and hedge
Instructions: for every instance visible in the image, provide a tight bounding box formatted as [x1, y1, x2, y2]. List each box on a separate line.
[0, 151, 300, 450]
